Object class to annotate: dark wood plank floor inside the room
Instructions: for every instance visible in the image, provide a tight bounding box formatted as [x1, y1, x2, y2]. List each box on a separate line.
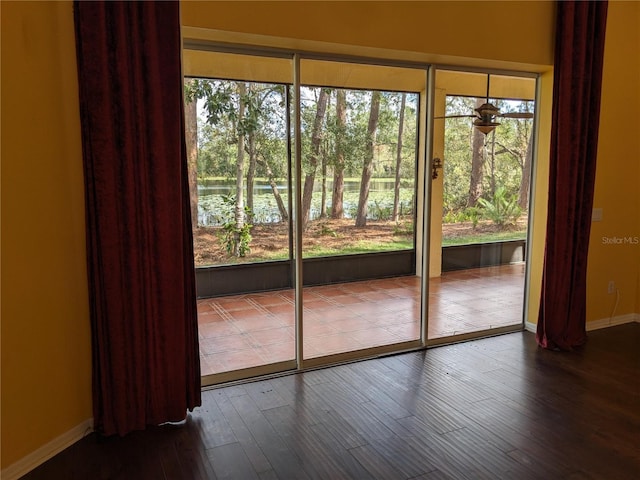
[25, 324, 640, 480]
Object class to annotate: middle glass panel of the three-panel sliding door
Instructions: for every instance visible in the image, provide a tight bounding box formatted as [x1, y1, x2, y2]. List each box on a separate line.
[300, 59, 426, 360]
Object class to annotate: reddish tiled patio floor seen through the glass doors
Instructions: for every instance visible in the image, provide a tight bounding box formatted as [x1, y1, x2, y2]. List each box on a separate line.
[198, 264, 525, 375]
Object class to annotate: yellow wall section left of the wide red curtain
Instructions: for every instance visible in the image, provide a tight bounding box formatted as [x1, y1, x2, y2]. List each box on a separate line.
[1, 1, 92, 468]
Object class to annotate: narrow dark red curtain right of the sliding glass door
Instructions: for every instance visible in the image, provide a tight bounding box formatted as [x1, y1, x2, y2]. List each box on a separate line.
[537, 1, 607, 350]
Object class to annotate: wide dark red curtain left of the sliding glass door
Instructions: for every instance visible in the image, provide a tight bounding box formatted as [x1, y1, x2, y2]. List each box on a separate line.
[74, 1, 200, 435]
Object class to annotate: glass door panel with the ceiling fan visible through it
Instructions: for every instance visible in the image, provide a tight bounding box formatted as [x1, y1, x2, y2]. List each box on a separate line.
[428, 70, 535, 340]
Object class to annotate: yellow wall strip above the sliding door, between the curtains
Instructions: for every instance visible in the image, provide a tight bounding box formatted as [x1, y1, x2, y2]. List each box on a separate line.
[182, 1, 555, 66]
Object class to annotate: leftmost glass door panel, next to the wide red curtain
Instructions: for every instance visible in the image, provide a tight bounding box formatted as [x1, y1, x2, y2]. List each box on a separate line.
[184, 50, 295, 384]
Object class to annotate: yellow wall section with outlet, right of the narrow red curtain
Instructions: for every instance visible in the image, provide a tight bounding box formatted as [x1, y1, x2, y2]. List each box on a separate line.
[587, 1, 640, 321]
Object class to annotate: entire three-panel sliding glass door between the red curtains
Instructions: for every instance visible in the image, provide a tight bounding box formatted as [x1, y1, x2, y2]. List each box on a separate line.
[184, 46, 535, 384]
